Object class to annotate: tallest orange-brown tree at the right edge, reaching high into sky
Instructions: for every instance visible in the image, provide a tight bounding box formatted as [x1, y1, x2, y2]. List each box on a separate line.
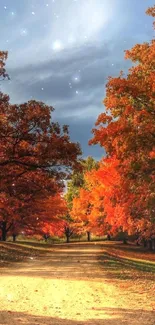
[90, 7, 155, 243]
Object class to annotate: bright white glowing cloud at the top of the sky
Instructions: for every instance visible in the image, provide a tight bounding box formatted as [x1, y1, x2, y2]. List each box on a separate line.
[5, 0, 121, 67]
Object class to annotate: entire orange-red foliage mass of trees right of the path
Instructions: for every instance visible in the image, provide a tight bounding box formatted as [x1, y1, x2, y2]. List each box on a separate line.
[72, 7, 155, 243]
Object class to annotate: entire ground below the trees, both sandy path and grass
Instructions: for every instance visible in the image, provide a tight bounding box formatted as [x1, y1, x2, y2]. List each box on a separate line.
[0, 242, 155, 325]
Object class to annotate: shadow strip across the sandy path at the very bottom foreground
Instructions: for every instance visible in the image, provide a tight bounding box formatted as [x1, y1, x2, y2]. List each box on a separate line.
[0, 308, 155, 325]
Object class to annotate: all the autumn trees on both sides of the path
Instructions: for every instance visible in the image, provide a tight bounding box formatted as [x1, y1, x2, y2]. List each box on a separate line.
[0, 7, 155, 249]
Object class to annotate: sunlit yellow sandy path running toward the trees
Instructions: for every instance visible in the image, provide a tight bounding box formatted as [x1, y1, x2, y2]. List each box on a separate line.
[0, 244, 155, 325]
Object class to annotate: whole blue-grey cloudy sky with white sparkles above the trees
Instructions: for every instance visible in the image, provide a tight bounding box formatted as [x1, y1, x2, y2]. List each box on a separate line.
[0, 0, 154, 159]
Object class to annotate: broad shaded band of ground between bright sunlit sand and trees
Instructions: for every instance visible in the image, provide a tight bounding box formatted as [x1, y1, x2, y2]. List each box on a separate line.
[2, 243, 155, 281]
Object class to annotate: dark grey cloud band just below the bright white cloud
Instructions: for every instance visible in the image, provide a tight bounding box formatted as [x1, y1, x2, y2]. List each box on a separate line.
[3, 42, 130, 107]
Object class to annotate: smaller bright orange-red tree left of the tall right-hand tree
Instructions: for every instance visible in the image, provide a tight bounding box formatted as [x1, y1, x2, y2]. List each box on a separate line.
[71, 158, 124, 240]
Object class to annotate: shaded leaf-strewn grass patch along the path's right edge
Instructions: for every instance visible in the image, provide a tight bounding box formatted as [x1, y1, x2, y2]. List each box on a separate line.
[99, 242, 155, 281]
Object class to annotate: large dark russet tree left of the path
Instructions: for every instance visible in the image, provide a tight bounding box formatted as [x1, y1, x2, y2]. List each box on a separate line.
[0, 52, 81, 240]
